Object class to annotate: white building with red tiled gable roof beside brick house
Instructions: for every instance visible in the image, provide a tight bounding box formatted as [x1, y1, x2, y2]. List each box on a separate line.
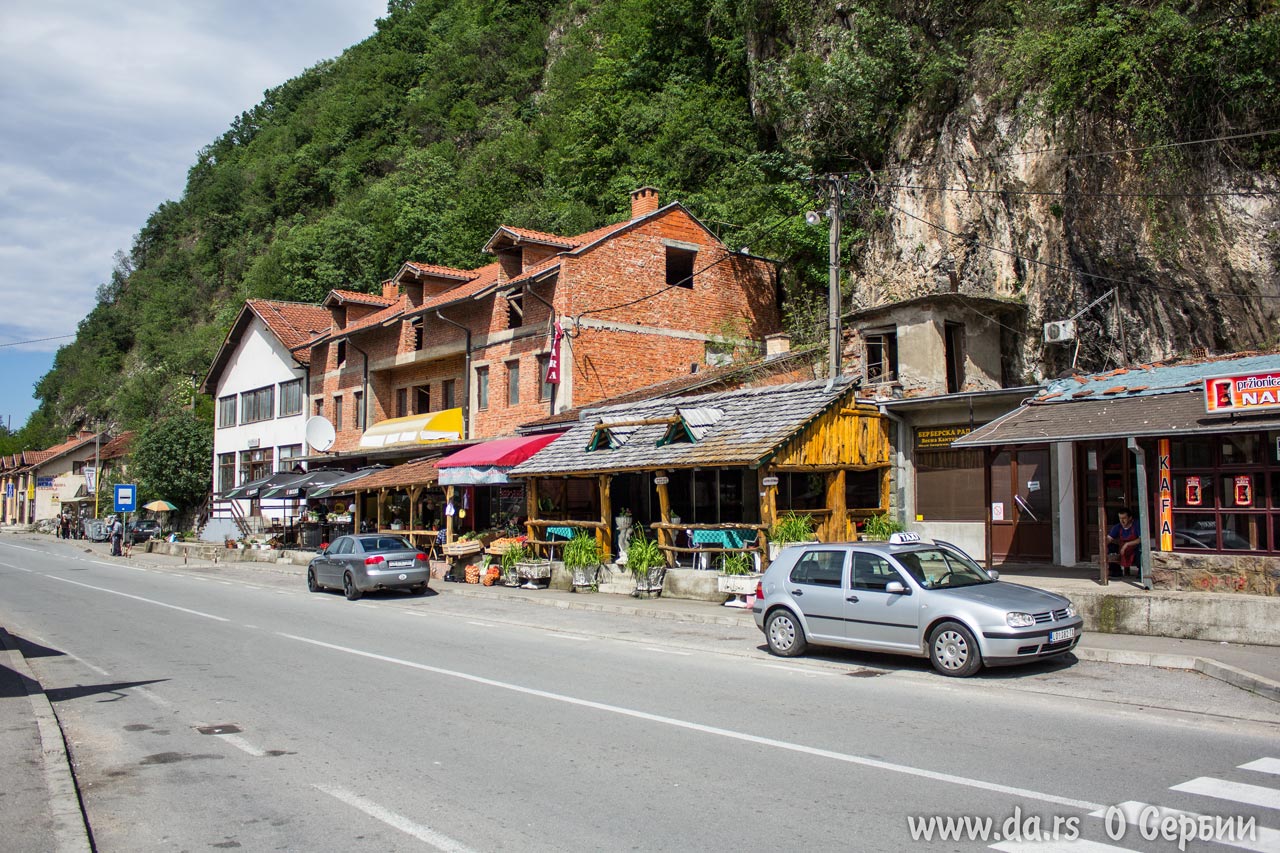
[201, 300, 332, 542]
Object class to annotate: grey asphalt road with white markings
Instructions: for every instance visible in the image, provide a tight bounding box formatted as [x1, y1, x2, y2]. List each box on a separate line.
[0, 537, 1280, 852]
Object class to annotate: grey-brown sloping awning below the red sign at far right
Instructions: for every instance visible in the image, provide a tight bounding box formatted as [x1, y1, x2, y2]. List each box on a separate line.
[951, 391, 1280, 448]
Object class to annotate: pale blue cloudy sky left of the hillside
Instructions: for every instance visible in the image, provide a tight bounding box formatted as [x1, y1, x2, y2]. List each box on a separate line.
[0, 0, 387, 429]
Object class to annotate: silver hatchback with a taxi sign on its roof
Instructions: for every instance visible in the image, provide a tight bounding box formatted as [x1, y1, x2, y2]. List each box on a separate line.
[753, 533, 1084, 676]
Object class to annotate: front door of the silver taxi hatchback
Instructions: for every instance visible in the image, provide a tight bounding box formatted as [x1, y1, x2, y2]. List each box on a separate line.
[846, 552, 920, 651]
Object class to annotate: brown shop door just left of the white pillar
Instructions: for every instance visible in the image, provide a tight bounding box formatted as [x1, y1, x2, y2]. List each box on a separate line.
[991, 447, 1053, 564]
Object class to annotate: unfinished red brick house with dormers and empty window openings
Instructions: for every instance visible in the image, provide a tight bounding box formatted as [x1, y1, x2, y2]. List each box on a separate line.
[300, 187, 781, 453]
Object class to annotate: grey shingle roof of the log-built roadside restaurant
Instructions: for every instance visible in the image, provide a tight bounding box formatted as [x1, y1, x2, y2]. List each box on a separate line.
[511, 377, 854, 476]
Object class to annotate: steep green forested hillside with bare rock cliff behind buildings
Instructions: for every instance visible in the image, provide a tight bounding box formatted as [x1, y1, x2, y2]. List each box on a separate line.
[12, 0, 1280, 450]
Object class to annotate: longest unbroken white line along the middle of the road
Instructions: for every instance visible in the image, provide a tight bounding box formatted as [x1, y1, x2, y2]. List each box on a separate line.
[276, 631, 1105, 812]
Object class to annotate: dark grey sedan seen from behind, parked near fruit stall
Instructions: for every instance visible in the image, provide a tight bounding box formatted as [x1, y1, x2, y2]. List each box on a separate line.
[307, 533, 431, 601]
